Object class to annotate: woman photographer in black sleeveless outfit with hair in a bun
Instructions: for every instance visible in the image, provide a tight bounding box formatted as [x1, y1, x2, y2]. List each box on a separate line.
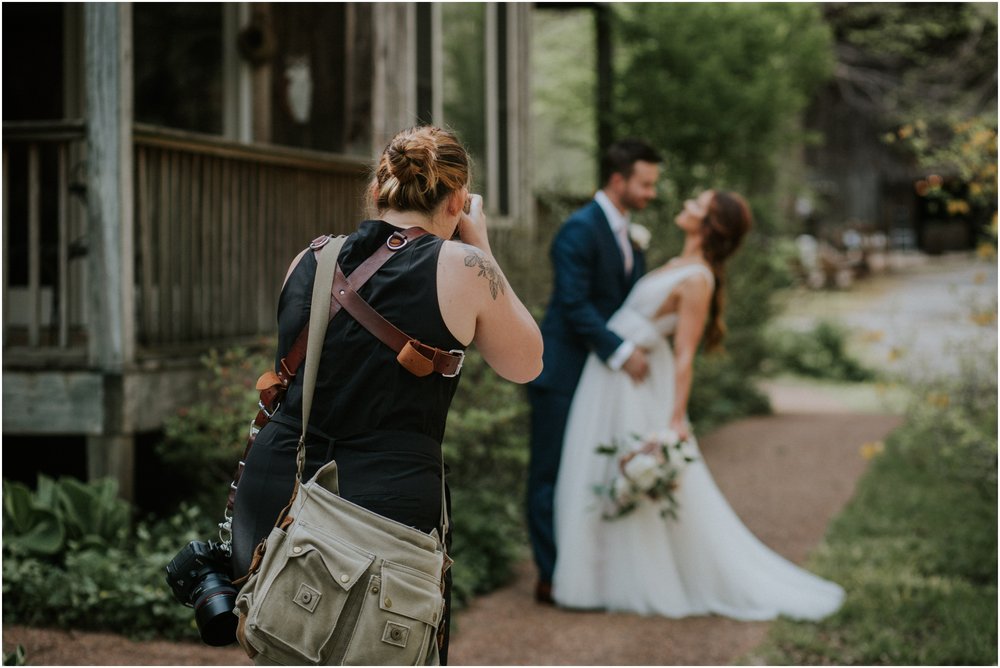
[233, 126, 542, 663]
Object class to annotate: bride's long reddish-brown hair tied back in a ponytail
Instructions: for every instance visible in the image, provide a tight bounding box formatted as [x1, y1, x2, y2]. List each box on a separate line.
[701, 190, 753, 351]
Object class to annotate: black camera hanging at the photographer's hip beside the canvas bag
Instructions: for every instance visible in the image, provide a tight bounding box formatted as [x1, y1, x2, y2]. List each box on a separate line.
[167, 541, 238, 647]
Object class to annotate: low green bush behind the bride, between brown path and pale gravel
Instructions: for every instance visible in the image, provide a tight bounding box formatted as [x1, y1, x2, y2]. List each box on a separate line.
[769, 321, 875, 381]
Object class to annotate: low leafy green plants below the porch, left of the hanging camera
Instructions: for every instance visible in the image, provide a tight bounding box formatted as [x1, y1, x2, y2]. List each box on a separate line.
[3, 479, 210, 639]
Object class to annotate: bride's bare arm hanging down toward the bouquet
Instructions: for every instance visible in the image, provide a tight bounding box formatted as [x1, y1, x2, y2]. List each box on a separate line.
[670, 276, 712, 439]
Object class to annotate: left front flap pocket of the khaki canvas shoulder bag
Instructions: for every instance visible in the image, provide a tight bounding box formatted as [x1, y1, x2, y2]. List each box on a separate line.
[248, 522, 375, 664]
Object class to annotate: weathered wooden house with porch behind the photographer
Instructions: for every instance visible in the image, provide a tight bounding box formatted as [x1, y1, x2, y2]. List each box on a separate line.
[3, 2, 534, 497]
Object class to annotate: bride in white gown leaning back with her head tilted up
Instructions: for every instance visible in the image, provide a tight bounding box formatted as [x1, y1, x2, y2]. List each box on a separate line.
[553, 190, 844, 620]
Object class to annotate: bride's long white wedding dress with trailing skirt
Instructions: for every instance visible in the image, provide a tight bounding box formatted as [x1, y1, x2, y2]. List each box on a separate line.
[552, 264, 844, 620]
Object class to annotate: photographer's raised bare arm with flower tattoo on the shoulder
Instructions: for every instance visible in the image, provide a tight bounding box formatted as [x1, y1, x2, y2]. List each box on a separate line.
[438, 196, 542, 383]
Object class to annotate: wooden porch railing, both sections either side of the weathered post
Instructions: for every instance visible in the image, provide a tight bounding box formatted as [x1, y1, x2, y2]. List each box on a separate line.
[3, 121, 367, 361]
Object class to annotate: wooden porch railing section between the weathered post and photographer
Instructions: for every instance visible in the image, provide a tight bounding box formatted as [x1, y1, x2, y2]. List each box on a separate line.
[134, 125, 367, 349]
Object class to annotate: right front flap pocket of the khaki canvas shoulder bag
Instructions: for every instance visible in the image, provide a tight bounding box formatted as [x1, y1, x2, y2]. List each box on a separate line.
[343, 561, 444, 666]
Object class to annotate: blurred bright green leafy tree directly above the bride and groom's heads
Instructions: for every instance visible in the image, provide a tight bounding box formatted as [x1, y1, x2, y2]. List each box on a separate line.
[613, 3, 833, 208]
